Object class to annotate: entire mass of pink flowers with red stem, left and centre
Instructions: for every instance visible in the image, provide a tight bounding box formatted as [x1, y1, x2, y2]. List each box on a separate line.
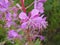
[0, 0, 48, 44]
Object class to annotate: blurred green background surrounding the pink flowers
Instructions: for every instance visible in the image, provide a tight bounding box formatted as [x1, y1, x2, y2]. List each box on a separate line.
[0, 0, 60, 45]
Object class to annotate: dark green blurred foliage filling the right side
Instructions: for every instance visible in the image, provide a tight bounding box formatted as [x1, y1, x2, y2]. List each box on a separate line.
[44, 0, 60, 45]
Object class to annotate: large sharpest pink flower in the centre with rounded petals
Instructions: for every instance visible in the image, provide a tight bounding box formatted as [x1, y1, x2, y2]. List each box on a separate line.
[19, 9, 47, 30]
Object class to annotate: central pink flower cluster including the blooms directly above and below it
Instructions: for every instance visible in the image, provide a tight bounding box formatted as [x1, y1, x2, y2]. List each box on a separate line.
[19, 0, 48, 40]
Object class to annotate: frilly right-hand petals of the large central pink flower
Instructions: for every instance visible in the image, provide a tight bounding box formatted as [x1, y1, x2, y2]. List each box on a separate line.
[33, 17, 47, 29]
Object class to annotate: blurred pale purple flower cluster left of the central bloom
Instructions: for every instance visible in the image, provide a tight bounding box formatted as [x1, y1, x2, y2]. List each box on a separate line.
[5, 7, 18, 28]
